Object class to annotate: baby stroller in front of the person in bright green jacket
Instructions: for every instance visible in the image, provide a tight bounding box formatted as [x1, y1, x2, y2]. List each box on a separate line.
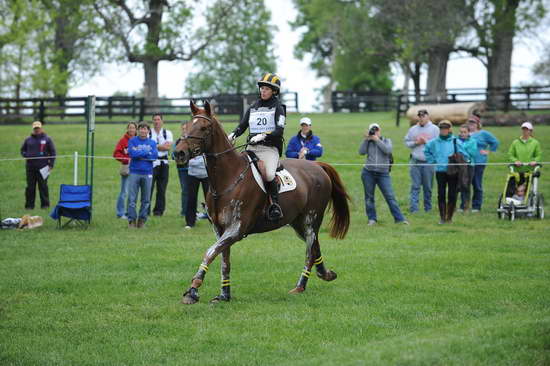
[497, 163, 544, 221]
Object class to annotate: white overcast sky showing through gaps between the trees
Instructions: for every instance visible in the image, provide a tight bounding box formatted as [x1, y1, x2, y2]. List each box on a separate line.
[70, 0, 550, 113]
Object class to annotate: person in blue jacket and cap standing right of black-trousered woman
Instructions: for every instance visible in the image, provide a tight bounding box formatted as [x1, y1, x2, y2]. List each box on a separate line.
[468, 115, 499, 212]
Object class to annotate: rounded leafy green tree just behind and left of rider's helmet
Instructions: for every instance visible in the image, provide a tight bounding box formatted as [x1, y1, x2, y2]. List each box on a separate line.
[185, 0, 277, 95]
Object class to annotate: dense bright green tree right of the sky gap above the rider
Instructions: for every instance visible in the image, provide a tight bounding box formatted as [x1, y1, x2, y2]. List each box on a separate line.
[291, 0, 392, 110]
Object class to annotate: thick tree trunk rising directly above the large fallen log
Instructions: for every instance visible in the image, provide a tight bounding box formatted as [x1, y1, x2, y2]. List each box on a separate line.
[426, 46, 452, 101]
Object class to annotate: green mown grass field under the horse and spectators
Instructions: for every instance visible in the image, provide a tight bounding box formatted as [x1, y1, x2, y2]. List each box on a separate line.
[0, 113, 550, 365]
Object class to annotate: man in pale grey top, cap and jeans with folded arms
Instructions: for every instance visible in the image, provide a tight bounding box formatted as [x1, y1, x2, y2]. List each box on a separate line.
[405, 109, 439, 213]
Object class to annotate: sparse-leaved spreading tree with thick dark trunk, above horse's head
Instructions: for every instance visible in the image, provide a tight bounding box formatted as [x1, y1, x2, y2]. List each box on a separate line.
[94, 0, 239, 104]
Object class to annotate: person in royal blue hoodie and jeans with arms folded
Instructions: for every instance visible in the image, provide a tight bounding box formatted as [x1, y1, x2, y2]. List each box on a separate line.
[128, 122, 158, 228]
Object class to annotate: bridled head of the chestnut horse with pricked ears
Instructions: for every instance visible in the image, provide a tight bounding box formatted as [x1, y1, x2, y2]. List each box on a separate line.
[175, 101, 219, 163]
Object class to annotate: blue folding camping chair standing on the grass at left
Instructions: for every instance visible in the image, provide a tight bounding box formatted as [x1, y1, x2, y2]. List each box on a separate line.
[50, 184, 92, 229]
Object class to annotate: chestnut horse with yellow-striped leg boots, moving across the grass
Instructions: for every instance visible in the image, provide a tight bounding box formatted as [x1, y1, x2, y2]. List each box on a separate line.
[176, 101, 350, 304]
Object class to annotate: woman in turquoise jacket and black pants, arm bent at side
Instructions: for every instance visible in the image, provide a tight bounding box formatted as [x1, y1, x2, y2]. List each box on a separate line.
[424, 120, 470, 224]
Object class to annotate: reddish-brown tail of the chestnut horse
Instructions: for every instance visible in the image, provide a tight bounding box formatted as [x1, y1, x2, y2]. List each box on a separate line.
[317, 161, 350, 239]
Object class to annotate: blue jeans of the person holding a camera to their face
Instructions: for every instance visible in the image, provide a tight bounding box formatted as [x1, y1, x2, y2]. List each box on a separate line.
[361, 168, 405, 222]
